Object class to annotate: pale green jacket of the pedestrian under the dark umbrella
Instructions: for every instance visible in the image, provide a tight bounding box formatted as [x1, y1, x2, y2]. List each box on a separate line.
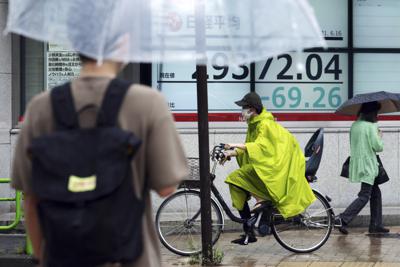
[349, 120, 383, 185]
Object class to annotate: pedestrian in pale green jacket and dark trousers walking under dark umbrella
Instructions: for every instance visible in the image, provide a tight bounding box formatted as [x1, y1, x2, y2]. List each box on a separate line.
[338, 101, 389, 235]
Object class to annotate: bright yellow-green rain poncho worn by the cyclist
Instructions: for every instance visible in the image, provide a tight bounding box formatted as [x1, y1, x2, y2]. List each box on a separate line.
[237, 109, 315, 217]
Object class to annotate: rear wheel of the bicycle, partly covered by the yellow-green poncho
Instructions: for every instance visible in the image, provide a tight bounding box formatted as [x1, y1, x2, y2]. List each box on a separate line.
[271, 190, 334, 253]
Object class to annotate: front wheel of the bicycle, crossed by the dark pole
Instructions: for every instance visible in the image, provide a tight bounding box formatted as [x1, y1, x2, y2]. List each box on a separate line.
[156, 190, 223, 256]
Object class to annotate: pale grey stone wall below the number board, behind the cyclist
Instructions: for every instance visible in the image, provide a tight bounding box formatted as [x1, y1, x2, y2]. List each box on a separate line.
[153, 127, 400, 224]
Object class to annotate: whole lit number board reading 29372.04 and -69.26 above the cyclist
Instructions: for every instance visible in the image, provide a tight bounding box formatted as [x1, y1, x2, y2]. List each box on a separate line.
[153, 53, 348, 112]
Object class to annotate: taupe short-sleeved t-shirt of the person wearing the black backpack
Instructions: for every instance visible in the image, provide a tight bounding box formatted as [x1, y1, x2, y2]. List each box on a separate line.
[11, 77, 188, 267]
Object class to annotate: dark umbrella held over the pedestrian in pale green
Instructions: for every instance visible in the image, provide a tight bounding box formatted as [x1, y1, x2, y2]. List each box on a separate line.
[335, 91, 400, 115]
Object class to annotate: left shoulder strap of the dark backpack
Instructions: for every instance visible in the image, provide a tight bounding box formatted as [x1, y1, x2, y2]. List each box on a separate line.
[50, 83, 79, 131]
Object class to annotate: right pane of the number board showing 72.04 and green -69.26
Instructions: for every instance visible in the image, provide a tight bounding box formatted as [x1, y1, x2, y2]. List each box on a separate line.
[256, 53, 348, 112]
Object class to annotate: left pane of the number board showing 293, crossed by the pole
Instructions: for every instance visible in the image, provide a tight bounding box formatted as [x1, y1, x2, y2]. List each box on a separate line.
[152, 56, 250, 113]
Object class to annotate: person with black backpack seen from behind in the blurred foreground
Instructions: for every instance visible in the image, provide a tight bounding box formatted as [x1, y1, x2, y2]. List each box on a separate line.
[12, 55, 188, 267]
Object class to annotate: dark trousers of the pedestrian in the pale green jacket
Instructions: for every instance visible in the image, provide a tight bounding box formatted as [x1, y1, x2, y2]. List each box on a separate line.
[340, 183, 383, 227]
